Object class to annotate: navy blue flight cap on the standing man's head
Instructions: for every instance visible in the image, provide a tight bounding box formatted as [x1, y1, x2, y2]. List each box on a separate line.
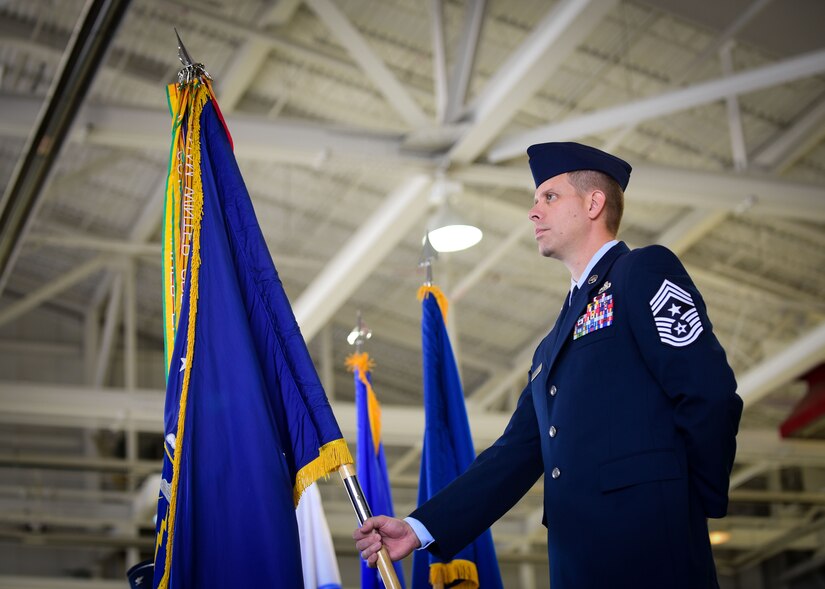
[527, 142, 632, 190]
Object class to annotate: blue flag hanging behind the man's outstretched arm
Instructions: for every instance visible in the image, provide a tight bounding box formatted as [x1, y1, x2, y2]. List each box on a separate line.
[412, 286, 502, 589]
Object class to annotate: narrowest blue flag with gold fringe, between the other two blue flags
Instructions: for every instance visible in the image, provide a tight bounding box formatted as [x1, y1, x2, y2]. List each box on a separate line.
[347, 353, 405, 589]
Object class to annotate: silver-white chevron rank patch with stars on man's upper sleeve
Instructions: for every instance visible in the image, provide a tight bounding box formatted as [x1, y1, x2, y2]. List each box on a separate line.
[650, 280, 703, 348]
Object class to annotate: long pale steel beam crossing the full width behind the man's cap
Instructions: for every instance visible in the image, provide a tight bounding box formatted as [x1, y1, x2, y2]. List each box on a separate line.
[0, 96, 825, 219]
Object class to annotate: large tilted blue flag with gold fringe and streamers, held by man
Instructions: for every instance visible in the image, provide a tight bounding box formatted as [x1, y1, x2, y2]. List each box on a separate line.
[153, 79, 352, 589]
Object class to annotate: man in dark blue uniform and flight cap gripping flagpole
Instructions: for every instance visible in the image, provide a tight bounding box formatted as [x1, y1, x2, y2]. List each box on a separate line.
[353, 143, 742, 589]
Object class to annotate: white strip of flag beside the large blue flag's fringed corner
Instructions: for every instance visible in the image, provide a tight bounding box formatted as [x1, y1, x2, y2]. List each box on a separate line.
[295, 483, 341, 589]
